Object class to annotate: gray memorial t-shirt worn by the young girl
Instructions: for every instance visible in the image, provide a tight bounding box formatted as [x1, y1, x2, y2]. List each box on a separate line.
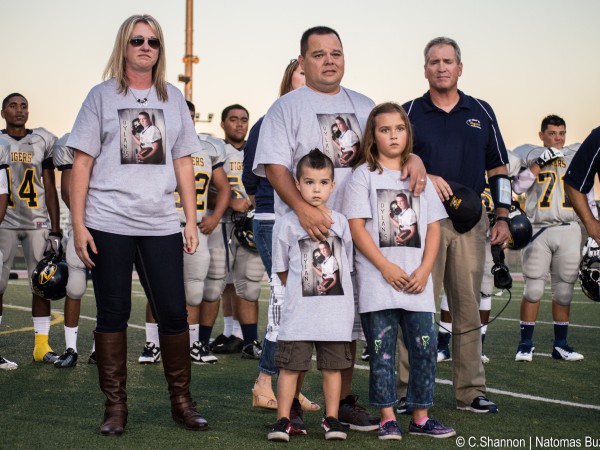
[342, 164, 448, 313]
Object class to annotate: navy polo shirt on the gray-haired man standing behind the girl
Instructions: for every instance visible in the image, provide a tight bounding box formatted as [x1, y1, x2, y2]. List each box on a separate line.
[403, 91, 508, 195]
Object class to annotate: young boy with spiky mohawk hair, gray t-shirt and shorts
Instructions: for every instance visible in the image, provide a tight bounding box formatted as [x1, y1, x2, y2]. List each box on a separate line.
[268, 149, 354, 442]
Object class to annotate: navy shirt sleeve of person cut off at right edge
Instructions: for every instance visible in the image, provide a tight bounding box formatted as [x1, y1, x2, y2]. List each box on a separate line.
[565, 127, 600, 194]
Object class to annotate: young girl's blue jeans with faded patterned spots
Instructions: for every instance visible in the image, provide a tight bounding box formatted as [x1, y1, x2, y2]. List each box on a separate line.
[360, 309, 437, 408]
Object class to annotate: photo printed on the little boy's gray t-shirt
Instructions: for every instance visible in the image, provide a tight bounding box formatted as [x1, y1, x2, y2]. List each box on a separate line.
[298, 236, 344, 297]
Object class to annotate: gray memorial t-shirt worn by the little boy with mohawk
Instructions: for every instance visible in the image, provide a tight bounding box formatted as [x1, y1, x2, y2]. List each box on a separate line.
[272, 211, 354, 342]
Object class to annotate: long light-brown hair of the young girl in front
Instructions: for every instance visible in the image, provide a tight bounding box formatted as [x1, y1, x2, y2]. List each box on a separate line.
[352, 102, 413, 173]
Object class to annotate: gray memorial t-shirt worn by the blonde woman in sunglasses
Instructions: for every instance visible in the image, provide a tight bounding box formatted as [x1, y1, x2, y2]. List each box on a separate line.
[67, 79, 201, 236]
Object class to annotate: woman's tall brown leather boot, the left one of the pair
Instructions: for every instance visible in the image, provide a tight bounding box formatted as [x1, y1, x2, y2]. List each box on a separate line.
[94, 331, 127, 436]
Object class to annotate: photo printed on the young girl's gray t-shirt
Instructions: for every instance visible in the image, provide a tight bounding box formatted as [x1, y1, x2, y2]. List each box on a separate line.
[377, 189, 421, 248]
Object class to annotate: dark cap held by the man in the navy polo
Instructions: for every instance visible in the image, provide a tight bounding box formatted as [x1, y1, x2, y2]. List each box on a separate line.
[443, 180, 483, 233]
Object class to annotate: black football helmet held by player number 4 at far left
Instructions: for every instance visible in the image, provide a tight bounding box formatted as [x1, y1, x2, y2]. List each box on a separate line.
[31, 254, 69, 300]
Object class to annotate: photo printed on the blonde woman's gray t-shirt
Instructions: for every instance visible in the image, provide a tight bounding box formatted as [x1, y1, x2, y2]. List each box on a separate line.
[119, 108, 166, 165]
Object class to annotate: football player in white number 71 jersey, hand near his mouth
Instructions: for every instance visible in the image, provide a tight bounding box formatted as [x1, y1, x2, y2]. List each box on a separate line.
[513, 115, 593, 361]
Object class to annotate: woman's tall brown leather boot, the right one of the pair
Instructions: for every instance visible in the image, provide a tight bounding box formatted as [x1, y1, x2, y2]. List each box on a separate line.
[159, 331, 208, 431]
